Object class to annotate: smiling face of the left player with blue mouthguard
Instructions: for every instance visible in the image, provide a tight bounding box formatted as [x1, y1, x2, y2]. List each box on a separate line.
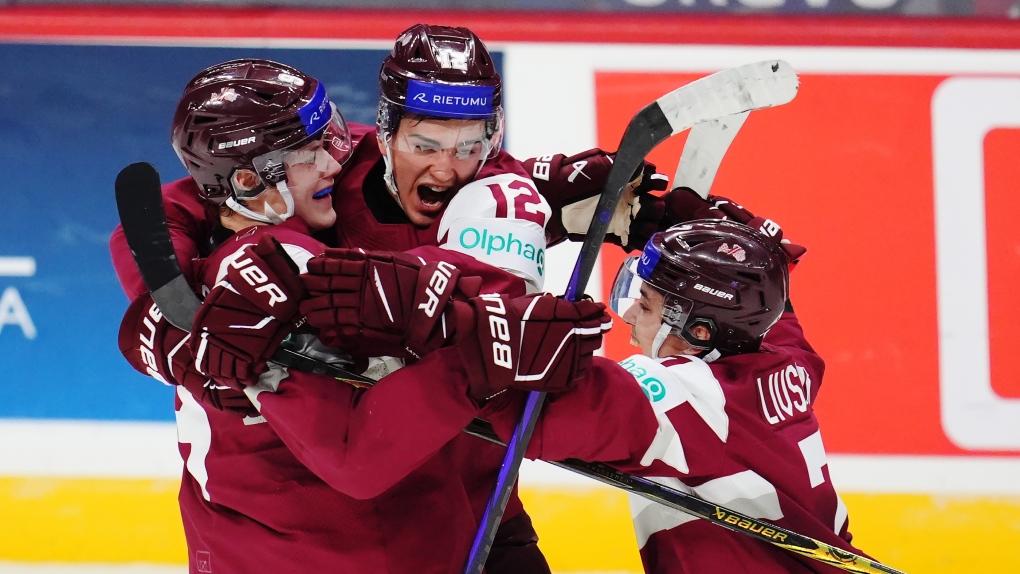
[285, 142, 341, 231]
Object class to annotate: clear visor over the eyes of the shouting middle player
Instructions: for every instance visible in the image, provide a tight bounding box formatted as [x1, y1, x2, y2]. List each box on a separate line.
[391, 120, 496, 161]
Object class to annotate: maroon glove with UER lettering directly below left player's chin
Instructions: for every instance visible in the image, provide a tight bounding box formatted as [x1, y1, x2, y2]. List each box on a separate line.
[189, 236, 305, 389]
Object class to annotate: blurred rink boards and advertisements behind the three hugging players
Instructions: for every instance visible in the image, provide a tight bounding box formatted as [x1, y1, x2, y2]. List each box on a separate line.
[0, 0, 1020, 573]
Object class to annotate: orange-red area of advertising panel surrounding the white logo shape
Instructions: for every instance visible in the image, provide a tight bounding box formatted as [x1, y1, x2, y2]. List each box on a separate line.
[596, 72, 1020, 455]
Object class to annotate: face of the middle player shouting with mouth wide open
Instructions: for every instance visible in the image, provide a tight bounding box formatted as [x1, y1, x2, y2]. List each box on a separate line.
[383, 116, 489, 227]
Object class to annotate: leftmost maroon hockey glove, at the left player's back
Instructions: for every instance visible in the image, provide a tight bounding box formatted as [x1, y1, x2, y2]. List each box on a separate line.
[118, 294, 258, 417]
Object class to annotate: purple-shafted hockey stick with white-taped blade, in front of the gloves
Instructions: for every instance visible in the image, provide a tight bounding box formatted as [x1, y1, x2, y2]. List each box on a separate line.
[464, 60, 798, 574]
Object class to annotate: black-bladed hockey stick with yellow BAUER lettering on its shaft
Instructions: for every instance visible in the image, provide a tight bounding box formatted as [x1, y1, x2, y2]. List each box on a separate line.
[116, 164, 899, 574]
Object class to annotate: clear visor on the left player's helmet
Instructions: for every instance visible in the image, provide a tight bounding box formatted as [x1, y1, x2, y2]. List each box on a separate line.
[246, 104, 353, 199]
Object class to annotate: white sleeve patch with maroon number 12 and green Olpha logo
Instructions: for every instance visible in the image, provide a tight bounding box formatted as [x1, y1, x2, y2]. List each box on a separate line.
[439, 173, 552, 292]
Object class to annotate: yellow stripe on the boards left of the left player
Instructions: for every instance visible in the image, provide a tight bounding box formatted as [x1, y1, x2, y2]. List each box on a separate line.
[0, 477, 188, 564]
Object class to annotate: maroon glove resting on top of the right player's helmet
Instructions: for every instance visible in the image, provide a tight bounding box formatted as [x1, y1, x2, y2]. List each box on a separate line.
[664, 188, 808, 267]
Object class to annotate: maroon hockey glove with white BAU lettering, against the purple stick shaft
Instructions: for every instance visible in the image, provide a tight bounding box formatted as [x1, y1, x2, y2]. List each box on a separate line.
[454, 294, 612, 401]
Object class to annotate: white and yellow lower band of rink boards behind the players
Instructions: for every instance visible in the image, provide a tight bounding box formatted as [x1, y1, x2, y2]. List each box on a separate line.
[0, 422, 1020, 574]
